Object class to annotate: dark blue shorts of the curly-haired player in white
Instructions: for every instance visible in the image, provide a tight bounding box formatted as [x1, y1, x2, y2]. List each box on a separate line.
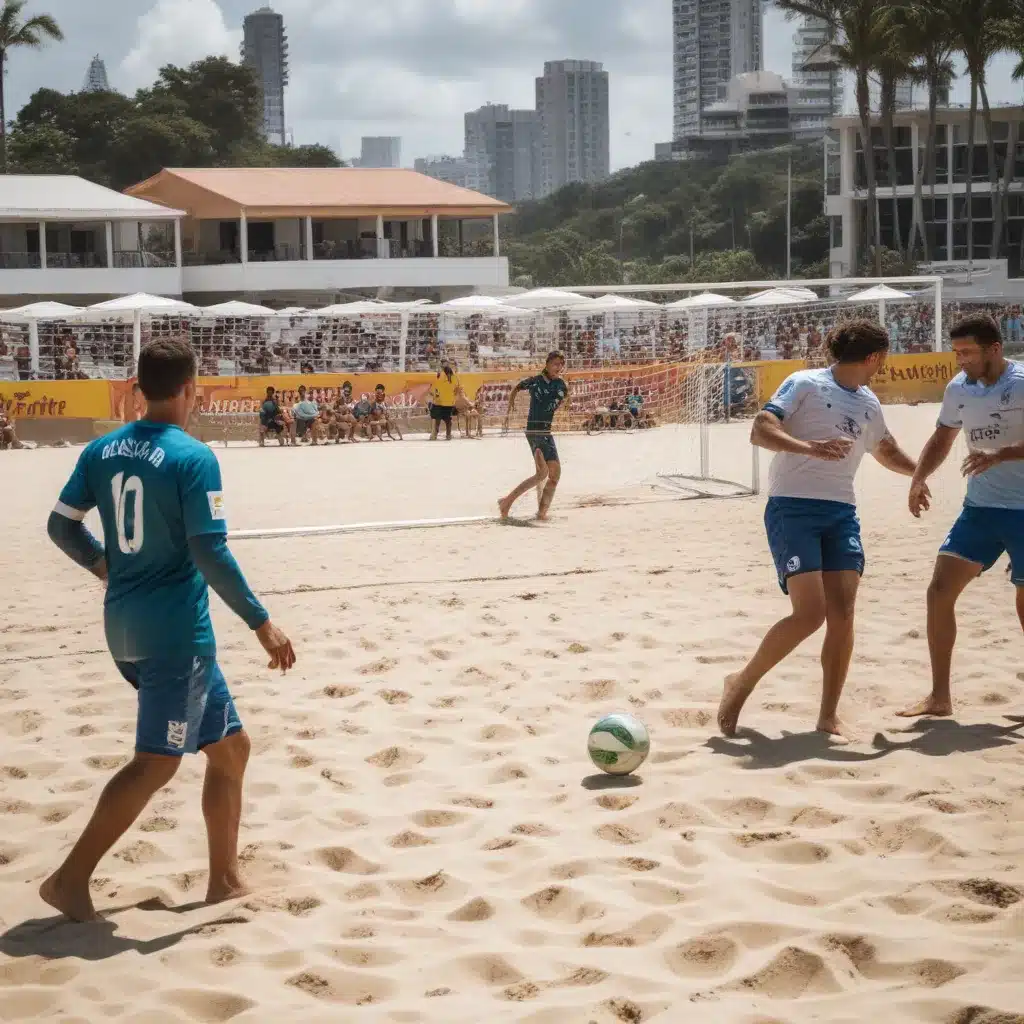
[765, 498, 864, 594]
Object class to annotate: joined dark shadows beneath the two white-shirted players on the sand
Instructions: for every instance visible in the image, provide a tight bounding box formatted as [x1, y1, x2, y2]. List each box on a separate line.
[707, 715, 1024, 769]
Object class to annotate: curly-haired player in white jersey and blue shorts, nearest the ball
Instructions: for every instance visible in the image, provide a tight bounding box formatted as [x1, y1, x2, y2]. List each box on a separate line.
[718, 319, 916, 737]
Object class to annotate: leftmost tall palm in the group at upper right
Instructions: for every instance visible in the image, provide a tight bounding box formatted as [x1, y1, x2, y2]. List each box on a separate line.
[776, 0, 895, 278]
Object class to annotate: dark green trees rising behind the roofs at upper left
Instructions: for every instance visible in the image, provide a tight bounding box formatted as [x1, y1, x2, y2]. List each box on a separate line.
[10, 57, 342, 188]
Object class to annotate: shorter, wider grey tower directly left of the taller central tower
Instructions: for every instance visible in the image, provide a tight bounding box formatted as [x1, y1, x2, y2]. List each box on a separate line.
[465, 103, 541, 203]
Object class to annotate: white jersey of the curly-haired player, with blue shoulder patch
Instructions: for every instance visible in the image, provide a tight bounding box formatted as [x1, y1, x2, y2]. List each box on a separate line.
[765, 369, 886, 505]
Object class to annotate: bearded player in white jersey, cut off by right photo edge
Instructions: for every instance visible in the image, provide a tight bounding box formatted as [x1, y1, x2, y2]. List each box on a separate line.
[900, 316, 1024, 718]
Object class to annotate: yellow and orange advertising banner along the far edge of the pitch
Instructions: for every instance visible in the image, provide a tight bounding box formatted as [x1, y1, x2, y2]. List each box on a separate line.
[0, 352, 956, 422]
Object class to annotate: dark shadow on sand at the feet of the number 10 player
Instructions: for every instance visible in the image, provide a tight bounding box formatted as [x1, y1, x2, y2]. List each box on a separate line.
[0, 899, 249, 961]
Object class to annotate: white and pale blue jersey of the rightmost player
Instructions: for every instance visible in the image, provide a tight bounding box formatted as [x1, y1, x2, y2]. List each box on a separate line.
[939, 362, 1024, 509]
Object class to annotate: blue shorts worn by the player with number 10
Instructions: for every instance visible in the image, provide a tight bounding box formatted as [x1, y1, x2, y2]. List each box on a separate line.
[116, 654, 242, 758]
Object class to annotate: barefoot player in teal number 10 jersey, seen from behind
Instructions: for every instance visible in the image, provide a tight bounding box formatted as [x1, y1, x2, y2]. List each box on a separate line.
[39, 339, 295, 921]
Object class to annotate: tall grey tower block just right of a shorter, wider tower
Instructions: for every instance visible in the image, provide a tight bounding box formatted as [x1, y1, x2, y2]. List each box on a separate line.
[537, 60, 611, 196]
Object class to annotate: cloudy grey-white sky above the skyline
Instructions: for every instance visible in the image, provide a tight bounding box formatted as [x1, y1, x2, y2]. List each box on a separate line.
[6, 0, 1021, 168]
